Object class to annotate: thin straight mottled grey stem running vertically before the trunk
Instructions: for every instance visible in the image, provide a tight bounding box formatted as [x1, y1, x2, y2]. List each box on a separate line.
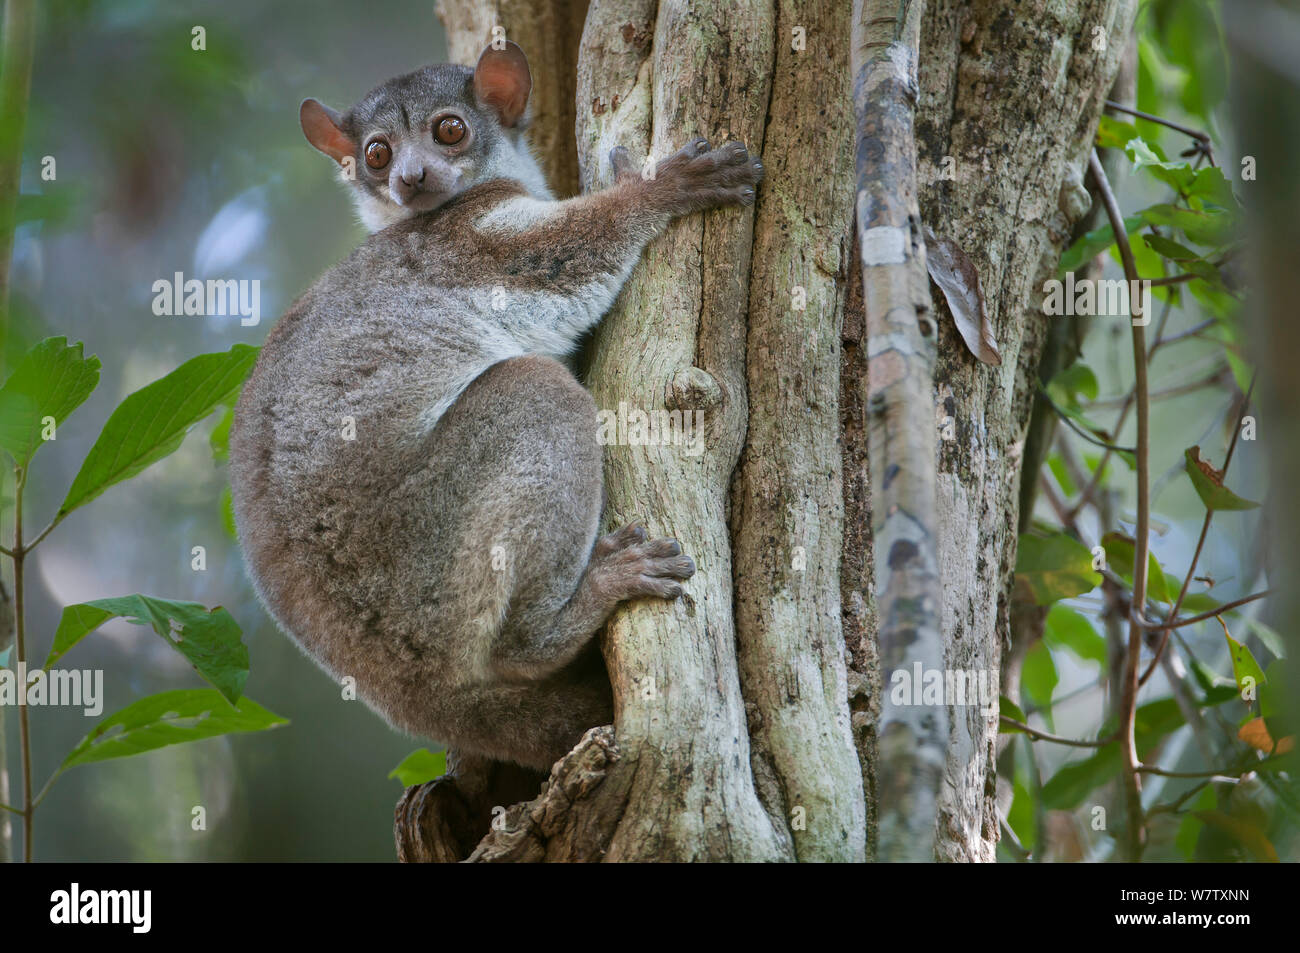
[853, 0, 948, 861]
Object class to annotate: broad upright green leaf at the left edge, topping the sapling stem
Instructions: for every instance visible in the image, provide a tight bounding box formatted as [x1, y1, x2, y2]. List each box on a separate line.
[0, 338, 99, 467]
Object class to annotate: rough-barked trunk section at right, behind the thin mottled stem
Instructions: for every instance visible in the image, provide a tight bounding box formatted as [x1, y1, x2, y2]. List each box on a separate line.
[917, 0, 1135, 861]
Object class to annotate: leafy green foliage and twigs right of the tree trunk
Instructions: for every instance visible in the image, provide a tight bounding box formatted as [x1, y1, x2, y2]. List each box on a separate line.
[1002, 0, 1300, 861]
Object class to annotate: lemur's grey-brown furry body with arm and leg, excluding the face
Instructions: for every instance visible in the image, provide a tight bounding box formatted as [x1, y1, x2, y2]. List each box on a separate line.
[231, 46, 762, 770]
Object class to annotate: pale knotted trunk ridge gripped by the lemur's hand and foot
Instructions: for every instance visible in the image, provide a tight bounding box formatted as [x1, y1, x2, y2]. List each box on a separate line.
[577, 0, 793, 861]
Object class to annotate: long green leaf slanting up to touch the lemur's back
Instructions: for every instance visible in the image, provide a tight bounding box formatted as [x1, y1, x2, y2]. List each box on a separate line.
[59, 345, 257, 516]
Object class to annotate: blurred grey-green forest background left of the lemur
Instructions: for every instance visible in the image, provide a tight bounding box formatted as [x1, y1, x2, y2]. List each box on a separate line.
[4, 0, 446, 861]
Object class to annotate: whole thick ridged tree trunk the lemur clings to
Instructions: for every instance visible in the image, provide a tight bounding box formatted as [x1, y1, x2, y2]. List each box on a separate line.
[397, 0, 1132, 861]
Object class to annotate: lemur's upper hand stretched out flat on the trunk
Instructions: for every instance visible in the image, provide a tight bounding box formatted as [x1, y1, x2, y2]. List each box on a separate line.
[610, 139, 763, 215]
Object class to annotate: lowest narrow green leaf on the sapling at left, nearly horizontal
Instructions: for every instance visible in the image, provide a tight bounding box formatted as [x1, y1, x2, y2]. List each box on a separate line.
[59, 688, 289, 771]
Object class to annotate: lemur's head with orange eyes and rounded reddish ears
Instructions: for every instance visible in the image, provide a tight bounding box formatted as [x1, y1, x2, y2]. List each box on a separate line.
[299, 42, 550, 231]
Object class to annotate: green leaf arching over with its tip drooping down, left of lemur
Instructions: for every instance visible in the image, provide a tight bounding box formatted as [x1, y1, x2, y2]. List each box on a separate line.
[44, 595, 248, 705]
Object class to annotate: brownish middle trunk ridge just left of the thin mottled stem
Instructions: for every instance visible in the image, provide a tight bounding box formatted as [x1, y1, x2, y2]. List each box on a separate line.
[732, 0, 866, 861]
